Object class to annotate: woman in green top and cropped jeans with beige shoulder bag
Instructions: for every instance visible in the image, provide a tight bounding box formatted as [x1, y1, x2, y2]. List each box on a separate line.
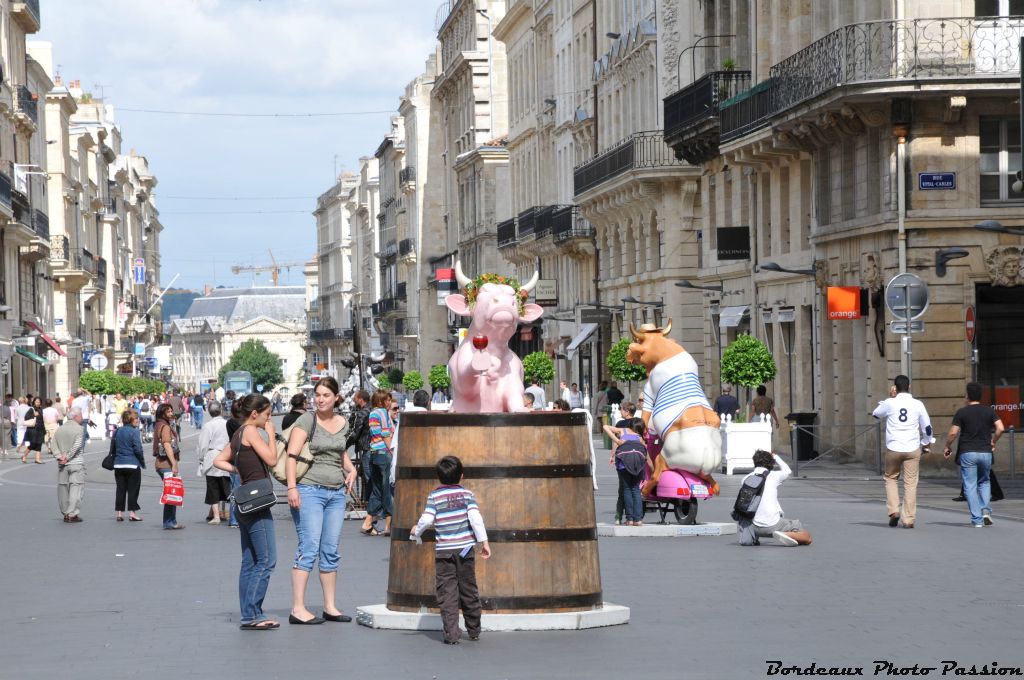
[287, 377, 355, 624]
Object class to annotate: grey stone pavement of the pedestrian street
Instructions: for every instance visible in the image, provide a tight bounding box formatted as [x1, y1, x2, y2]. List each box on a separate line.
[0, 429, 1024, 680]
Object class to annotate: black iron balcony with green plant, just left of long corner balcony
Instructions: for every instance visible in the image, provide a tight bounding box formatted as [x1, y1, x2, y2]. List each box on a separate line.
[665, 71, 751, 165]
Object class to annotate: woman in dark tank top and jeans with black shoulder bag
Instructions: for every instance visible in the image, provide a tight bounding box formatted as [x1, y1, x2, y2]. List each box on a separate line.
[213, 393, 281, 631]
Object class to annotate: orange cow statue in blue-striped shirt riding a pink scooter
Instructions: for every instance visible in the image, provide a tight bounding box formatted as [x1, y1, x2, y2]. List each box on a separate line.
[626, 318, 722, 496]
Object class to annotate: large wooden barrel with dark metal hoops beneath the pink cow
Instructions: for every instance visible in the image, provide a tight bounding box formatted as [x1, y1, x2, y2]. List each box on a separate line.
[387, 412, 602, 613]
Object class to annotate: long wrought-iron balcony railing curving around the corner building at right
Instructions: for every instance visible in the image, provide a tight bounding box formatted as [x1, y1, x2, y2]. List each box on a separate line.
[720, 16, 1024, 141]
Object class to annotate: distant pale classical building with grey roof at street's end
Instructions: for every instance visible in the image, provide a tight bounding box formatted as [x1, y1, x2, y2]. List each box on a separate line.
[170, 286, 306, 389]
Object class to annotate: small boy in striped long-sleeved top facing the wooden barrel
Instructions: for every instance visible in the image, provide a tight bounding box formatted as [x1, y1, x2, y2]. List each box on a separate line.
[410, 456, 490, 644]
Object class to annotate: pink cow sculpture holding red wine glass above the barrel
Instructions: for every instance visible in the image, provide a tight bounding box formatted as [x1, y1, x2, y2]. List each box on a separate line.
[444, 262, 544, 413]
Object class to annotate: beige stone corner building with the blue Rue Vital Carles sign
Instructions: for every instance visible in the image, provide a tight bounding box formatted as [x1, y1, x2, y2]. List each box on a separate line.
[665, 0, 1024, 460]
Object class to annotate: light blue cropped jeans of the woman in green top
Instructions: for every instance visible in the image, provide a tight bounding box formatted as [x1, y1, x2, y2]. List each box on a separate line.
[291, 483, 347, 573]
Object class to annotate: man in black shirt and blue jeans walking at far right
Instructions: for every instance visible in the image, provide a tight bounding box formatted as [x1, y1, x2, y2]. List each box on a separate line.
[943, 382, 1002, 527]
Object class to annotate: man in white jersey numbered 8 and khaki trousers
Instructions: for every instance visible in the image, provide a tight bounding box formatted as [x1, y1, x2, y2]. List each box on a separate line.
[871, 376, 935, 528]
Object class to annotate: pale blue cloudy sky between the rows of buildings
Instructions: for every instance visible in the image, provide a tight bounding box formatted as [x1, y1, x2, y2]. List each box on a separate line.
[38, 0, 440, 290]
